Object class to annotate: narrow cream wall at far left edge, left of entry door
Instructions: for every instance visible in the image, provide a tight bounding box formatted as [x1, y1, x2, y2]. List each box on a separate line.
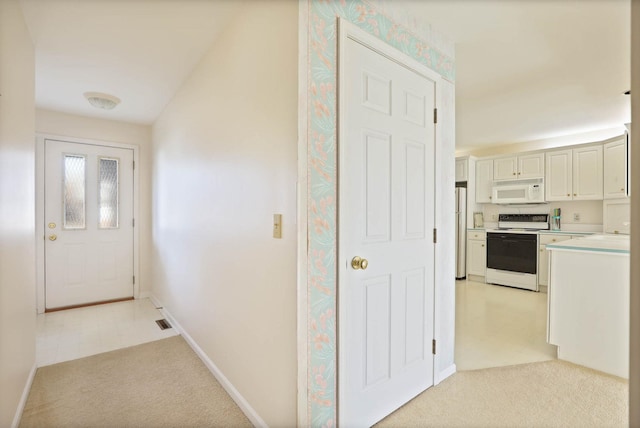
[0, 0, 36, 427]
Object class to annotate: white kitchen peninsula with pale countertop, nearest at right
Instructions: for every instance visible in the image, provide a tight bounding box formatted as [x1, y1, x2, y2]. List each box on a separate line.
[547, 235, 630, 378]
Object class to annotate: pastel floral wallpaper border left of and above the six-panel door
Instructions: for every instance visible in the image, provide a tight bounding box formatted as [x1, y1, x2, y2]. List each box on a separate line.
[307, 0, 455, 428]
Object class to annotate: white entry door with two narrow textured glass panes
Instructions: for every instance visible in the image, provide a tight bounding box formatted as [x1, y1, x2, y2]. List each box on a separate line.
[44, 140, 134, 310]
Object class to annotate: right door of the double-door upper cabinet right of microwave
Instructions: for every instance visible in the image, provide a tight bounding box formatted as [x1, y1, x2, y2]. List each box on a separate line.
[573, 145, 603, 200]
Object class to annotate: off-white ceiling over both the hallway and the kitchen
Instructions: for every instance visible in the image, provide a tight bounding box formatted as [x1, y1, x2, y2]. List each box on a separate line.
[21, 0, 631, 150]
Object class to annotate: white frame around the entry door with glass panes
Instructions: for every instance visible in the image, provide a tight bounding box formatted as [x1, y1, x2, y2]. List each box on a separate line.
[35, 133, 140, 314]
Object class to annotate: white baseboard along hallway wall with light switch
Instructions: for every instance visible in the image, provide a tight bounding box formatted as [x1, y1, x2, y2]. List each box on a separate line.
[149, 295, 268, 427]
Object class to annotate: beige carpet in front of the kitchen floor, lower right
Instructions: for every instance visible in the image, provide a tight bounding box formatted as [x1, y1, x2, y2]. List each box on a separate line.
[376, 360, 629, 428]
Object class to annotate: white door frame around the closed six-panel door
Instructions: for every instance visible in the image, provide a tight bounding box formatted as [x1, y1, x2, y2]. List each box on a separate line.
[336, 19, 443, 426]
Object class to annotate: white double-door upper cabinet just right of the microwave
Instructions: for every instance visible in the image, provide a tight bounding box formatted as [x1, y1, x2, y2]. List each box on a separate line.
[545, 145, 603, 201]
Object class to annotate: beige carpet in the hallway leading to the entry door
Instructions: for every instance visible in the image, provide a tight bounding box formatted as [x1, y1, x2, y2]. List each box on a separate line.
[20, 336, 252, 427]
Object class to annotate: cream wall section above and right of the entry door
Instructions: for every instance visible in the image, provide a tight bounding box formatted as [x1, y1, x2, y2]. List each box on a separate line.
[36, 109, 151, 296]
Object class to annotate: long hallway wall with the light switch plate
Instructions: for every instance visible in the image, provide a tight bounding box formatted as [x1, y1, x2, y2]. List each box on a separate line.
[152, 0, 298, 426]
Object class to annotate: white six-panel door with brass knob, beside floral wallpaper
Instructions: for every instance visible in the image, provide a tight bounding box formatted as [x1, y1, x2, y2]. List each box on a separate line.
[338, 28, 436, 428]
